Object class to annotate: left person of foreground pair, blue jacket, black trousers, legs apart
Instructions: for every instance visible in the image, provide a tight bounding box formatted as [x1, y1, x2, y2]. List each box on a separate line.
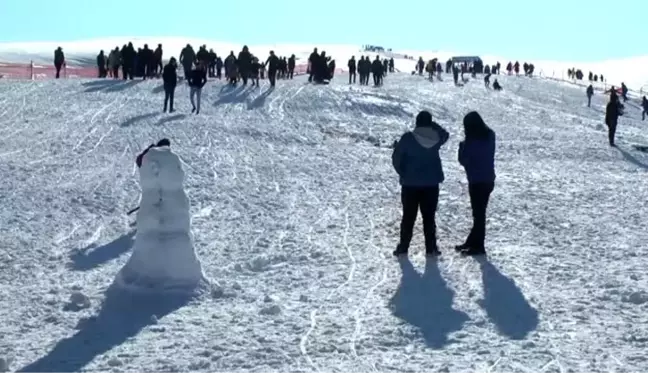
[392, 111, 450, 255]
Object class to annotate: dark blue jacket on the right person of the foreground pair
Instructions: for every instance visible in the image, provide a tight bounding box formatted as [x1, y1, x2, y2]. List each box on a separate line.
[459, 131, 495, 184]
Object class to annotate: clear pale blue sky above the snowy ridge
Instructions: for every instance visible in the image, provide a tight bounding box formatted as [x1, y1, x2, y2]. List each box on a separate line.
[0, 0, 648, 61]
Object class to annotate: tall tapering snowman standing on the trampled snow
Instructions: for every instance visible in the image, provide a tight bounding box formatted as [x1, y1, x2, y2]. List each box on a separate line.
[115, 146, 206, 293]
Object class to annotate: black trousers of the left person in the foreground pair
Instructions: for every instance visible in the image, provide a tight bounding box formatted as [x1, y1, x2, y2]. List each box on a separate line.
[399, 186, 439, 251]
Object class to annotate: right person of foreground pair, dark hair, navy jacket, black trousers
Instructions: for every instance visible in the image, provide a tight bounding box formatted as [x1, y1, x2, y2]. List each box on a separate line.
[455, 111, 495, 255]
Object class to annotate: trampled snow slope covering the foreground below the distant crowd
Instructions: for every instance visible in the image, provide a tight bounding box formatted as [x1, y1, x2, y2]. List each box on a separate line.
[0, 70, 648, 373]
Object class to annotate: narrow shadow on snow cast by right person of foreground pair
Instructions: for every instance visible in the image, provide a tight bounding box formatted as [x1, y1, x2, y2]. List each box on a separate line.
[475, 256, 539, 340]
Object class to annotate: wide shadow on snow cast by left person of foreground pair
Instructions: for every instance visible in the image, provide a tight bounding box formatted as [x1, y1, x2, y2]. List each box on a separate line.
[390, 258, 469, 349]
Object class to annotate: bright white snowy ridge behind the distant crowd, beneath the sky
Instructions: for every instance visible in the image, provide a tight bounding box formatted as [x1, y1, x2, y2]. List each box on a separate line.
[0, 36, 648, 92]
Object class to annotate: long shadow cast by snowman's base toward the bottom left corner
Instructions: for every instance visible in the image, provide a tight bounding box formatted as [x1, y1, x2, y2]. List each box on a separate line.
[17, 285, 192, 373]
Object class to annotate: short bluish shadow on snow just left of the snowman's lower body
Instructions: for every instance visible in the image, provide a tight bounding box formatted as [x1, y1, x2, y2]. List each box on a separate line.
[70, 230, 136, 271]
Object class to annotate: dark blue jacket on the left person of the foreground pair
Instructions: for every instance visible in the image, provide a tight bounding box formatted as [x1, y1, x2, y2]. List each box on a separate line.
[392, 122, 450, 187]
